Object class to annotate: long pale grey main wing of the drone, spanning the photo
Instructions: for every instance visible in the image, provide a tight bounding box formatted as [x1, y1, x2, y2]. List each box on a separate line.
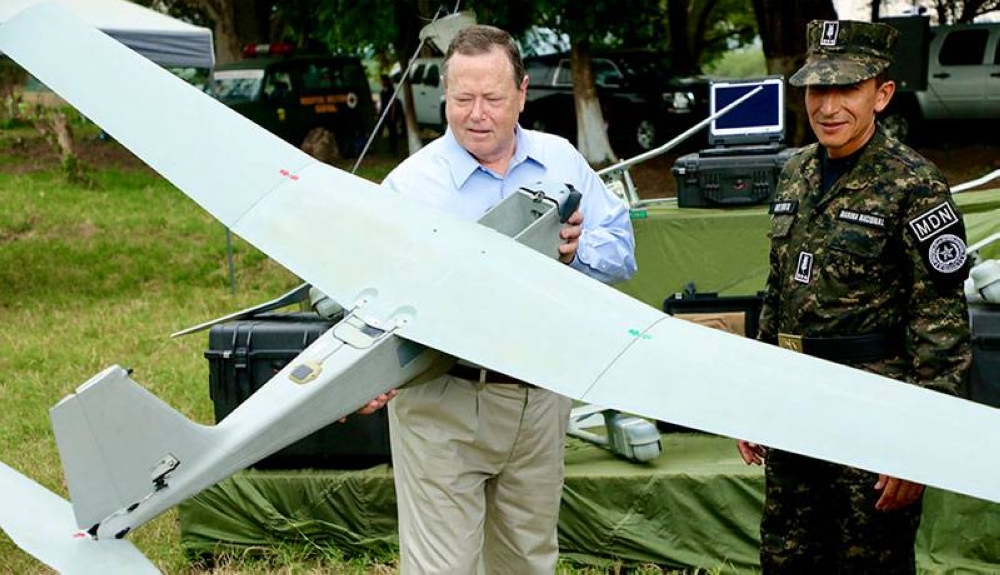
[0, 2, 1000, 532]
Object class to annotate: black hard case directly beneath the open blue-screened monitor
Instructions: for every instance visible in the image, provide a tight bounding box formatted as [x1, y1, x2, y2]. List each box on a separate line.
[672, 146, 796, 208]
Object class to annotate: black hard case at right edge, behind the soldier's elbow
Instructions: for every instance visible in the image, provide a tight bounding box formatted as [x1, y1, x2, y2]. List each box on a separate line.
[968, 303, 1000, 407]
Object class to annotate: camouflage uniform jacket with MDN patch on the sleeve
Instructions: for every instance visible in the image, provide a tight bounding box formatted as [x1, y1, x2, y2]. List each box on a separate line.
[759, 130, 971, 393]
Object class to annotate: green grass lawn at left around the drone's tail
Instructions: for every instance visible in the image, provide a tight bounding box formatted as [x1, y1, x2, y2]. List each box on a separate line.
[0, 155, 297, 573]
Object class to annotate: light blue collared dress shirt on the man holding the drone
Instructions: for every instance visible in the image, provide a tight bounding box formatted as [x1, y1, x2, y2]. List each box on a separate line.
[382, 126, 636, 283]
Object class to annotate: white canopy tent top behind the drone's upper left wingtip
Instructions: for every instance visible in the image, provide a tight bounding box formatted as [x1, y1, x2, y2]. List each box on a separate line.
[0, 0, 215, 68]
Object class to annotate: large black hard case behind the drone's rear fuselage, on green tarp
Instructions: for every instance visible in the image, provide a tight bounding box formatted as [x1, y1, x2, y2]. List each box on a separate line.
[205, 312, 390, 469]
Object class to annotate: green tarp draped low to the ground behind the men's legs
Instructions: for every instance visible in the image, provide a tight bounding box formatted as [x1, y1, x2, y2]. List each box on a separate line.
[180, 433, 1000, 575]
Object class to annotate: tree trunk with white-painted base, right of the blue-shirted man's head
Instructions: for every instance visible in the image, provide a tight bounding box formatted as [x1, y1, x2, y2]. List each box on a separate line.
[570, 40, 617, 165]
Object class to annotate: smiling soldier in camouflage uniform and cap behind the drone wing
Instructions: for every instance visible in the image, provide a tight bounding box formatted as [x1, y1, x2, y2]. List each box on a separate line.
[738, 21, 971, 575]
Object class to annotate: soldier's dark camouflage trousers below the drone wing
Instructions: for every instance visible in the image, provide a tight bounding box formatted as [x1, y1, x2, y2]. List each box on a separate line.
[760, 449, 921, 575]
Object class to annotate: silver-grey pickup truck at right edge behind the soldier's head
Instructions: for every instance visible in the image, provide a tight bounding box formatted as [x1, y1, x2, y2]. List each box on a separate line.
[881, 19, 1000, 141]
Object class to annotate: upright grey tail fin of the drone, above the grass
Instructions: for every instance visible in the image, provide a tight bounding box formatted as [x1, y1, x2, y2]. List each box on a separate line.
[50, 366, 213, 535]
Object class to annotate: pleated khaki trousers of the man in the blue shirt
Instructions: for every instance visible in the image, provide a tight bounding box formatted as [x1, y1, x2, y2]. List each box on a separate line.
[389, 375, 571, 575]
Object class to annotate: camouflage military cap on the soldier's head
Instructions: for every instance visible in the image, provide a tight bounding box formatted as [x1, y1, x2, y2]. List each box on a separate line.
[788, 20, 899, 86]
